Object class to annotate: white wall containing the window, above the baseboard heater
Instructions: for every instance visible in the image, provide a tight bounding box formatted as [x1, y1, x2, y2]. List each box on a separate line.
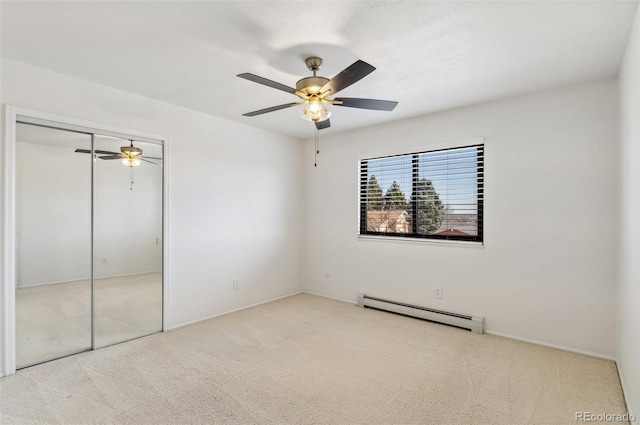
[303, 80, 618, 357]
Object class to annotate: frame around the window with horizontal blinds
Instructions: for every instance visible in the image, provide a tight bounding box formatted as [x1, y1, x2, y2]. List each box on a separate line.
[358, 142, 486, 245]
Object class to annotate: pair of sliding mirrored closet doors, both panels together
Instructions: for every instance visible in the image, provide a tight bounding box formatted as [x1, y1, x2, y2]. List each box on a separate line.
[15, 123, 163, 369]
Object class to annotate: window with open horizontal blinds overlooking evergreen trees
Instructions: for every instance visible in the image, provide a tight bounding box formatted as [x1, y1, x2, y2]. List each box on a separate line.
[360, 145, 484, 242]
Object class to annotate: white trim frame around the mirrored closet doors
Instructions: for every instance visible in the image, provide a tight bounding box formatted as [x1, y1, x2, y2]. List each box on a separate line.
[0, 105, 169, 376]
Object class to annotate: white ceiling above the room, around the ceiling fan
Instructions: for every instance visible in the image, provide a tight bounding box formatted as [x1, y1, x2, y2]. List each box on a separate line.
[0, 0, 638, 138]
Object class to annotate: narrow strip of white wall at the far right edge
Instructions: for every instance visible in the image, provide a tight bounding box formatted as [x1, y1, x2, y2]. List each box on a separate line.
[617, 4, 640, 416]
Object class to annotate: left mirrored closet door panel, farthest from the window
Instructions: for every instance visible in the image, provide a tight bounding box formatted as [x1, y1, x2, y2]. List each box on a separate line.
[16, 123, 92, 368]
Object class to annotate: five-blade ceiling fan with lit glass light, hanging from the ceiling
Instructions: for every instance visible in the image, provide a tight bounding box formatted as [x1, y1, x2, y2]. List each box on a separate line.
[238, 57, 398, 130]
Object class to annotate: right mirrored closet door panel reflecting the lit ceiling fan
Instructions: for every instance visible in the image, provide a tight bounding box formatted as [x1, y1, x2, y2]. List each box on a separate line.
[94, 135, 162, 348]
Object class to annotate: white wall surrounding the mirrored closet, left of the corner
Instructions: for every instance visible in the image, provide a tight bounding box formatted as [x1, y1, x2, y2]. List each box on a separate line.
[0, 59, 302, 372]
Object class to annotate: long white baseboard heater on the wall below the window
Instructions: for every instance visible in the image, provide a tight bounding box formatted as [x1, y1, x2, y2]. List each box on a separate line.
[358, 294, 484, 334]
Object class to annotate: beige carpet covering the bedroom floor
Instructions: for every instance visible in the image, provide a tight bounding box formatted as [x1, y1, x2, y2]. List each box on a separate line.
[0, 295, 626, 425]
